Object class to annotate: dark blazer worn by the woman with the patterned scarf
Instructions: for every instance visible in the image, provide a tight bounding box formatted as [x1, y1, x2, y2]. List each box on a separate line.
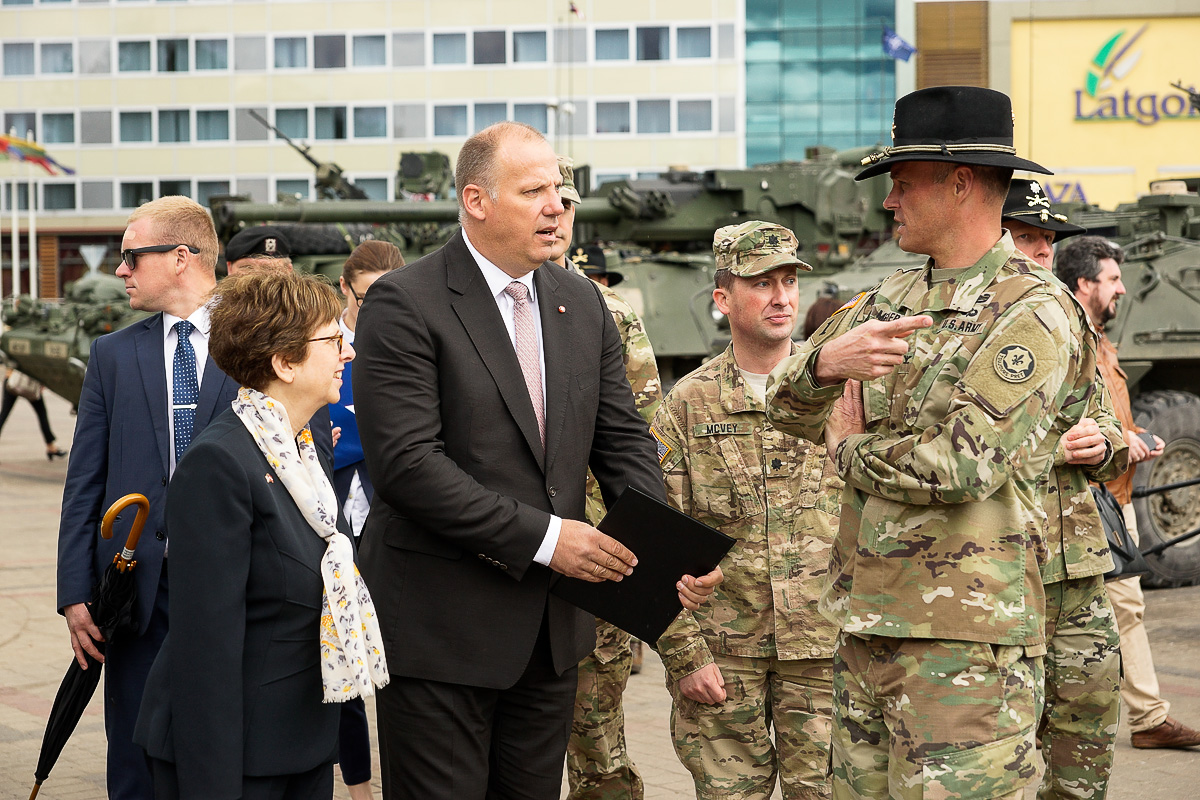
[134, 409, 341, 800]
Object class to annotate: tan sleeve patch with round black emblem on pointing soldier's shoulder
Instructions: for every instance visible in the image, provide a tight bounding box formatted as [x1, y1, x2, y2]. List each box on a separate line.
[962, 312, 1069, 416]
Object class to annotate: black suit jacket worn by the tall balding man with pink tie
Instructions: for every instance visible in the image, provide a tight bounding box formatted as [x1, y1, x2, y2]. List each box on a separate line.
[354, 231, 664, 688]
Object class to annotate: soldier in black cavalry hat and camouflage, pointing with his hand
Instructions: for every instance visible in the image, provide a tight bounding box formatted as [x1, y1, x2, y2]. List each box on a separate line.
[768, 86, 1096, 800]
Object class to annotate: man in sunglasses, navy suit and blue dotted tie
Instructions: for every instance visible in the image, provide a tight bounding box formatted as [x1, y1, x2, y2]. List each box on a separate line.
[58, 197, 238, 800]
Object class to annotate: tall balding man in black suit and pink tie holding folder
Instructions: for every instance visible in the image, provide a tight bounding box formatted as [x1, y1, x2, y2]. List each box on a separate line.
[354, 122, 719, 800]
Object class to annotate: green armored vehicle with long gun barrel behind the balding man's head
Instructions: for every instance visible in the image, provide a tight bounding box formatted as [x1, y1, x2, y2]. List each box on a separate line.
[214, 148, 890, 383]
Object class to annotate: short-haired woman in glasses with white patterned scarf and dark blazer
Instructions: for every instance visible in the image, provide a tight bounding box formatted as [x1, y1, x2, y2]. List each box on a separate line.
[134, 272, 388, 800]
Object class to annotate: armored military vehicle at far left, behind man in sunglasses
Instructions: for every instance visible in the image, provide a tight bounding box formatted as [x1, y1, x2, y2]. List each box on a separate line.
[0, 270, 148, 404]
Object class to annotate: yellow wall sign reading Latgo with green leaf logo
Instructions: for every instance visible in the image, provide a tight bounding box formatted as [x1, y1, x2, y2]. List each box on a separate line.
[1010, 17, 1200, 207]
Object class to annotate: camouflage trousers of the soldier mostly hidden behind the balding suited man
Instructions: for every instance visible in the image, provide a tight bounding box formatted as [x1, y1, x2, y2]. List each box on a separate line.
[566, 620, 643, 800]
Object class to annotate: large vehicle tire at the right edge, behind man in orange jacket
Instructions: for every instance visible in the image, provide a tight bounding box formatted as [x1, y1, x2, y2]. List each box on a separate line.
[1133, 391, 1200, 587]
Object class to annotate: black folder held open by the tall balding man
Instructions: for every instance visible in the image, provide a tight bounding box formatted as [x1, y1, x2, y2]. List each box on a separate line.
[551, 487, 733, 645]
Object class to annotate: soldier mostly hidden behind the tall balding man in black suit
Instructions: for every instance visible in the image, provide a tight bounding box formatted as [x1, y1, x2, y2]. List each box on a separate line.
[551, 157, 662, 800]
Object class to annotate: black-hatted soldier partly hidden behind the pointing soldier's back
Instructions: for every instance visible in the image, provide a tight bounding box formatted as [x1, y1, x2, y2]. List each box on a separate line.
[1001, 179, 1129, 800]
